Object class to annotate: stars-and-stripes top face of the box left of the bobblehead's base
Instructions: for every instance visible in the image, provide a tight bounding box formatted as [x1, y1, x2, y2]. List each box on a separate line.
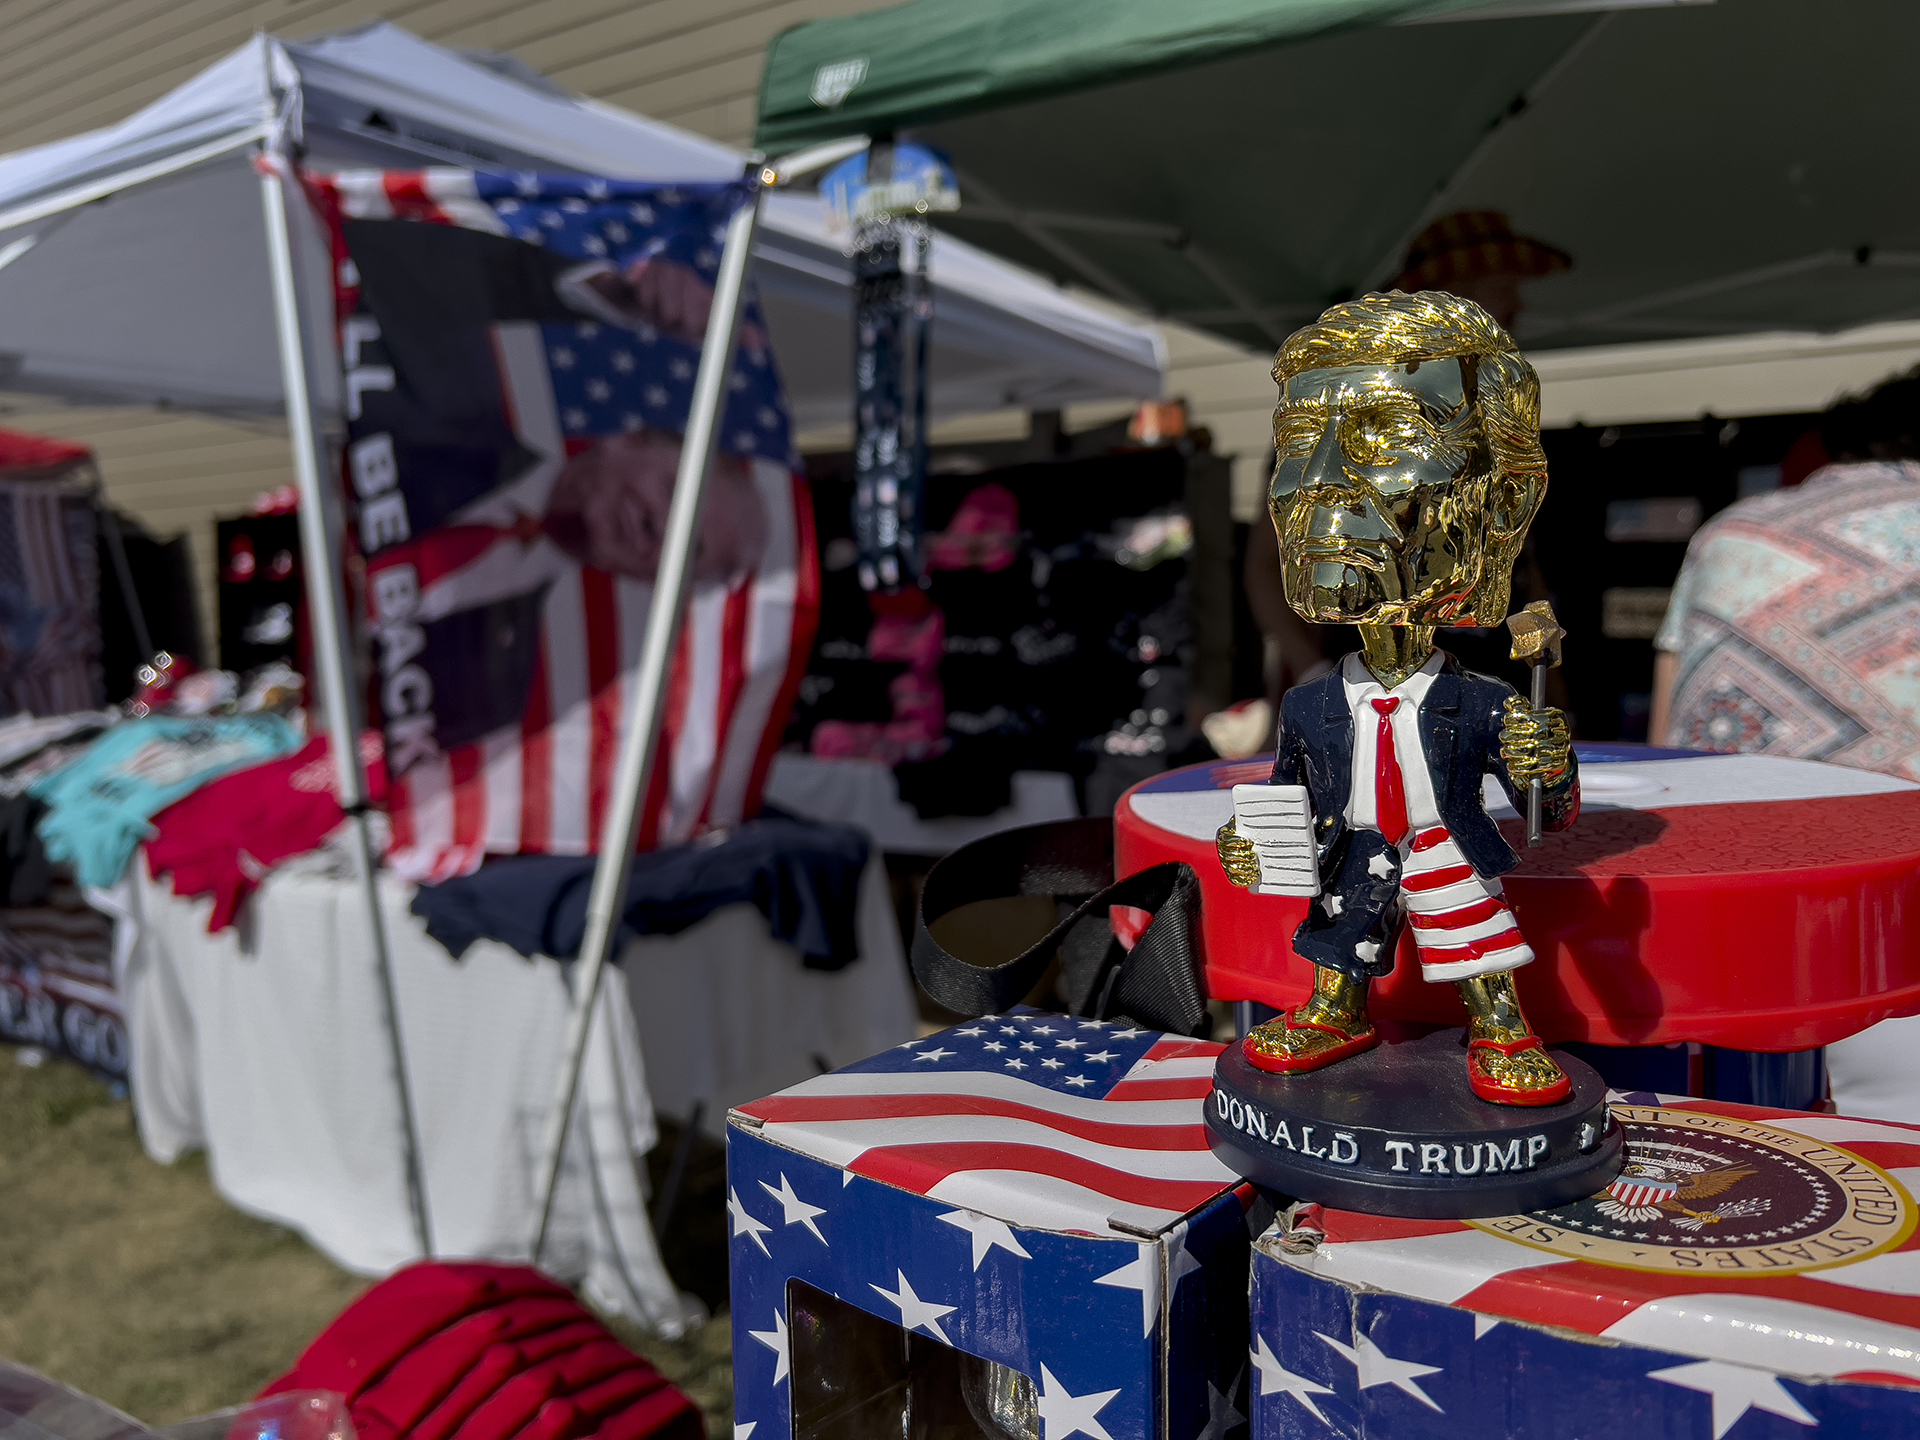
[739, 1012, 1240, 1238]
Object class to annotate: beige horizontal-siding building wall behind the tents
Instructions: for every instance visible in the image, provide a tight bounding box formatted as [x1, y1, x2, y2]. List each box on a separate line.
[0, 0, 1273, 639]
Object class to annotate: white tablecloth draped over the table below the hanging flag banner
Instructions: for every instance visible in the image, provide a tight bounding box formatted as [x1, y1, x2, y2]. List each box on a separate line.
[98, 856, 914, 1331]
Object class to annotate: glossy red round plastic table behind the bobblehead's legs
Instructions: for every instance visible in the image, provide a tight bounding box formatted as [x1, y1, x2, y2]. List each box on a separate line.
[1114, 745, 1920, 1050]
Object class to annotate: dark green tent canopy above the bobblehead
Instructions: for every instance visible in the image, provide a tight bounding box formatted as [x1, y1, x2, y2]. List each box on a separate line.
[756, 0, 1920, 349]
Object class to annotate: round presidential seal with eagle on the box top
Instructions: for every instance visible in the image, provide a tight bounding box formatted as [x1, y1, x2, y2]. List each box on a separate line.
[1469, 1106, 1920, 1277]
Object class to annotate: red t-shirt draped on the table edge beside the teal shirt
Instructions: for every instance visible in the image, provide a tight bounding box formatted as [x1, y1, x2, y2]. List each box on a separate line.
[146, 732, 386, 935]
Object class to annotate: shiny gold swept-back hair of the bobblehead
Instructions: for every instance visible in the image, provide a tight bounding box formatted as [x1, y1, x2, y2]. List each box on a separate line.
[1273, 290, 1548, 626]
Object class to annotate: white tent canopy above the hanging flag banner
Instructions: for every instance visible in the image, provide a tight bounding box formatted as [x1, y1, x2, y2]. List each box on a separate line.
[0, 23, 1162, 430]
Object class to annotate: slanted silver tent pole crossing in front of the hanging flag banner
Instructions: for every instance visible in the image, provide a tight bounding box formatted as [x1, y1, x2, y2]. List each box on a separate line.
[532, 188, 760, 1265]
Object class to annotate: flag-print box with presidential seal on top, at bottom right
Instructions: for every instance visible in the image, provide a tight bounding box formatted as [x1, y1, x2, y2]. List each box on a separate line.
[1250, 1094, 1920, 1440]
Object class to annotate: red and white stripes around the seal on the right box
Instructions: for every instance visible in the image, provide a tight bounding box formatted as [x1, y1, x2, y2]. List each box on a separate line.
[1288, 1098, 1920, 1386]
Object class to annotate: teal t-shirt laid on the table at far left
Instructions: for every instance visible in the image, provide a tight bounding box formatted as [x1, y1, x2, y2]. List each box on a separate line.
[29, 714, 303, 885]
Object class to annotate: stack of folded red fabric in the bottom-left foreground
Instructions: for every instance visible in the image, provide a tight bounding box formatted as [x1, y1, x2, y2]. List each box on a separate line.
[261, 1261, 707, 1440]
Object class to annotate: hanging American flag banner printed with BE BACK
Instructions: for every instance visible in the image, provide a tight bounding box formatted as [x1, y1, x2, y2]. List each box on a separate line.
[303, 169, 818, 881]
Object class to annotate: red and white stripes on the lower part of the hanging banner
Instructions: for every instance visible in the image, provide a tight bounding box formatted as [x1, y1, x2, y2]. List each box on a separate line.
[388, 461, 820, 883]
